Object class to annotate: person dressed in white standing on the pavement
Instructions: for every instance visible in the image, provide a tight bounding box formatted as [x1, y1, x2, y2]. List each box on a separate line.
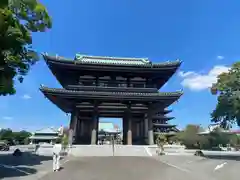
[53, 141, 62, 171]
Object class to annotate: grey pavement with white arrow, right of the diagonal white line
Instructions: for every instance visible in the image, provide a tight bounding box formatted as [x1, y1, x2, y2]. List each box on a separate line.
[154, 155, 240, 180]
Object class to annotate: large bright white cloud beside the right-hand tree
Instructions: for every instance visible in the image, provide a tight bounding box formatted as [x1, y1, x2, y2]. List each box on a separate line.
[178, 65, 229, 91]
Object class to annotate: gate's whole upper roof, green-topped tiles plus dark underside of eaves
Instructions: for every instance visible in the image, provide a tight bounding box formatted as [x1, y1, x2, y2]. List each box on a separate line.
[43, 54, 182, 89]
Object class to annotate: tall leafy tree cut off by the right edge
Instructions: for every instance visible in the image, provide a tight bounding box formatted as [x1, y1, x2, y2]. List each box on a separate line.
[211, 62, 240, 128]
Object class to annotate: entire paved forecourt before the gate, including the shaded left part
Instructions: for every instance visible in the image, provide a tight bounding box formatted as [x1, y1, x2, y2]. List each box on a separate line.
[0, 151, 240, 180]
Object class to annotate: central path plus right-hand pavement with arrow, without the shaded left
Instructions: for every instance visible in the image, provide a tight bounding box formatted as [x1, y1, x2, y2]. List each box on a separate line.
[40, 156, 240, 180]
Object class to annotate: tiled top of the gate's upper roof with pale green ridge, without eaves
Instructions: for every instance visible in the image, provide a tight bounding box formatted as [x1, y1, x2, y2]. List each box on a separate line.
[43, 54, 182, 68]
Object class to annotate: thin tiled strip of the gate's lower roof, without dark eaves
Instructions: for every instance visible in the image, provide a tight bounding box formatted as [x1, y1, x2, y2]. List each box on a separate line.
[40, 86, 183, 97]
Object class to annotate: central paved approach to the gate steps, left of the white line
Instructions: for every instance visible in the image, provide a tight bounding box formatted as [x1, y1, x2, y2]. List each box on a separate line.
[41, 156, 194, 180]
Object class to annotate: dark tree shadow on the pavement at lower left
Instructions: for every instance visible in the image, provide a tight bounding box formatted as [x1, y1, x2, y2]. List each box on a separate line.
[0, 152, 52, 179]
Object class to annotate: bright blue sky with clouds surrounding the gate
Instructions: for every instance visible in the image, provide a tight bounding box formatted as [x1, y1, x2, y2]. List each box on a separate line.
[0, 0, 240, 130]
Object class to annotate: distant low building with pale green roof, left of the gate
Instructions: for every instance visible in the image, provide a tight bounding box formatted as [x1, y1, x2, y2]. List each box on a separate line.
[29, 128, 59, 144]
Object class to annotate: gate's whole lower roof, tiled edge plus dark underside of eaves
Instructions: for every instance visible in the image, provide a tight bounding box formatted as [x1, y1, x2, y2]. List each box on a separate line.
[40, 87, 183, 113]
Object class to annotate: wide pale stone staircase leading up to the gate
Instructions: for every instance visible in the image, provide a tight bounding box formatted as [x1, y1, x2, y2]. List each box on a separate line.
[69, 145, 149, 156]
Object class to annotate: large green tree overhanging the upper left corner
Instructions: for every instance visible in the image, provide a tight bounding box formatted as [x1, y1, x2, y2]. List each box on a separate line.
[0, 0, 52, 95]
